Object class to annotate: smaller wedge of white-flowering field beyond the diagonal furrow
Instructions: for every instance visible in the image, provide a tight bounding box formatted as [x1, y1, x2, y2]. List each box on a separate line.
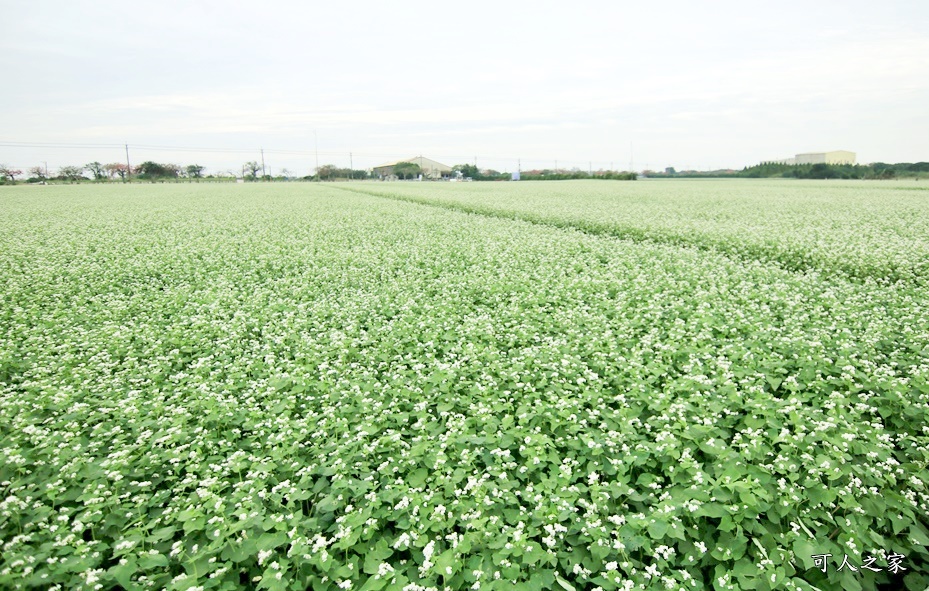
[344, 180, 929, 285]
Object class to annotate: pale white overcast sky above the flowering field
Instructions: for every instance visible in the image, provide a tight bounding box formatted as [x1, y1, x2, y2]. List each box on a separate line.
[0, 0, 929, 174]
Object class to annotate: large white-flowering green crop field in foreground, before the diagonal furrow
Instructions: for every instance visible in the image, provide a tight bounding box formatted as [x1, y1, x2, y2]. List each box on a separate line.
[0, 185, 929, 591]
